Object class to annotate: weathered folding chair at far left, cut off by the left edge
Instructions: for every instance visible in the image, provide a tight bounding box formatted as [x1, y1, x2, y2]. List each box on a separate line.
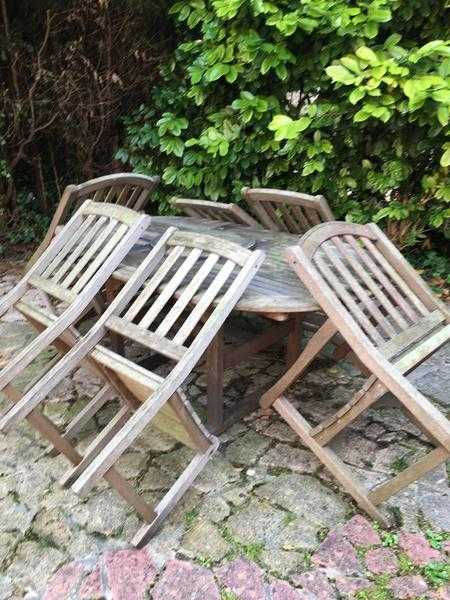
[0, 201, 150, 431]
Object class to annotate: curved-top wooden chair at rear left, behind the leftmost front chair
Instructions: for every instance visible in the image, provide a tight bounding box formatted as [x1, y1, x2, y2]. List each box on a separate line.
[26, 173, 159, 270]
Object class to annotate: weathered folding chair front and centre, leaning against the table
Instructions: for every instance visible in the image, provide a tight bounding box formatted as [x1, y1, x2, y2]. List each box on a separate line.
[3, 229, 264, 545]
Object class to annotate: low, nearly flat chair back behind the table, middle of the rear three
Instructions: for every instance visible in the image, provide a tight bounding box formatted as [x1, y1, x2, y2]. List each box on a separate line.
[170, 198, 260, 229]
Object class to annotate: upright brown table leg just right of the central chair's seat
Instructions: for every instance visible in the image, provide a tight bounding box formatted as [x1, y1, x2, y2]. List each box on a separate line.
[206, 327, 224, 432]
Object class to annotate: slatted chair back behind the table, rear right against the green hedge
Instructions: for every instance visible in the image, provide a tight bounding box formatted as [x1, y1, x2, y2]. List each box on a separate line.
[242, 188, 334, 234]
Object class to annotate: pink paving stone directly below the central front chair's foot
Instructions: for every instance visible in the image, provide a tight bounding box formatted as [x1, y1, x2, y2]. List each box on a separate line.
[102, 549, 158, 600]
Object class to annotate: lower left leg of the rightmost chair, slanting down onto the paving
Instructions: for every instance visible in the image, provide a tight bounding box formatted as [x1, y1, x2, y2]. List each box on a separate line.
[273, 396, 389, 526]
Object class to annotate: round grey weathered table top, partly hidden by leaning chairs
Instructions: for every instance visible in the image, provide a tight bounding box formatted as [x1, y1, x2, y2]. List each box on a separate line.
[114, 216, 319, 320]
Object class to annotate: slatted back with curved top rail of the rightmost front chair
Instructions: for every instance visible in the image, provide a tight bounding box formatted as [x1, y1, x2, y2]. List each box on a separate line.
[301, 223, 448, 360]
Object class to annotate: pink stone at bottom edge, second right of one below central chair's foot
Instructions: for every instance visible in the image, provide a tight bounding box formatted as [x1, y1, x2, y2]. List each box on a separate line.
[215, 558, 265, 600]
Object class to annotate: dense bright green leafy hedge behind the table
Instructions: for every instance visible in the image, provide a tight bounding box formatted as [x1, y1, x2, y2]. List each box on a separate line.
[117, 0, 450, 246]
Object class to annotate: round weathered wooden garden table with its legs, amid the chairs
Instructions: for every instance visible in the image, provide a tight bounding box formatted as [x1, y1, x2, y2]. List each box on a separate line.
[108, 216, 319, 433]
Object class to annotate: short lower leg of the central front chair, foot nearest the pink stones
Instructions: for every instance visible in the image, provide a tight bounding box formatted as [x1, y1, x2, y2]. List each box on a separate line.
[132, 438, 219, 548]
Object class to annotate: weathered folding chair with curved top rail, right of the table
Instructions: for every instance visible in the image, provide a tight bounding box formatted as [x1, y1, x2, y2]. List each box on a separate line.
[261, 223, 450, 522]
